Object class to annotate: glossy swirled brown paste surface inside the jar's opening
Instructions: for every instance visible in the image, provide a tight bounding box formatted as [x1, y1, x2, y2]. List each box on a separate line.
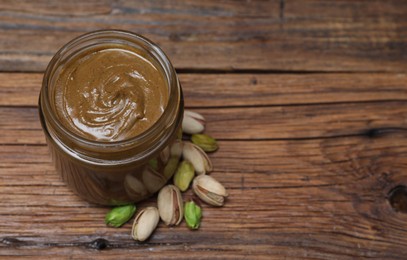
[54, 44, 168, 141]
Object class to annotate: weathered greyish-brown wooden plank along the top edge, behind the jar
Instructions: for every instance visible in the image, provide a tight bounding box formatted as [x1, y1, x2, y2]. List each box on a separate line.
[0, 0, 407, 72]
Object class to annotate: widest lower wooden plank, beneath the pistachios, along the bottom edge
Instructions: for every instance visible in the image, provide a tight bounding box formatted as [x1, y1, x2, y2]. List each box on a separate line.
[0, 135, 407, 259]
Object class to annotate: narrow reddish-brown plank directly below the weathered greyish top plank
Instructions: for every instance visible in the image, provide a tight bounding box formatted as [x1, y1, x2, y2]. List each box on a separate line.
[0, 73, 407, 108]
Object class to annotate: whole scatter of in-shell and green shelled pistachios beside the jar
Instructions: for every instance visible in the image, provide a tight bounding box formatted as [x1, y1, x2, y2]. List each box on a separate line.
[105, 110, 228, 241]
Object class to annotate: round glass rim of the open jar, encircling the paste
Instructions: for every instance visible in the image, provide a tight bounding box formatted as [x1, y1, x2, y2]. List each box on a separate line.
[41, 30, 180, 147]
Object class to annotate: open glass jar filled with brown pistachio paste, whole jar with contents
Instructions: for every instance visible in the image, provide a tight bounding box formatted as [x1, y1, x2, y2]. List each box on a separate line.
[39, 30, 183, 205]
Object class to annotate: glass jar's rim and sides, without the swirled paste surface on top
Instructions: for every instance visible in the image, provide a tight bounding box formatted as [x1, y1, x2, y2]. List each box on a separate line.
[39, 30, 183, 205]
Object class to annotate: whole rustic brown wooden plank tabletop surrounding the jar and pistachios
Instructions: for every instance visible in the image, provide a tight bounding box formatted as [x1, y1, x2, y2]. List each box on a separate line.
[0, 0, 407, 259]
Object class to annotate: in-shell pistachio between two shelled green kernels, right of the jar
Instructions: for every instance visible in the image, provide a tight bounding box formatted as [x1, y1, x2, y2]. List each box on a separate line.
[182, 142, 213, 175]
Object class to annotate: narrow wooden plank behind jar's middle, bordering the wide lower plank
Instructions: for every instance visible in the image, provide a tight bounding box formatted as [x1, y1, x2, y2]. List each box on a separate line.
[0, 101, 407, 144]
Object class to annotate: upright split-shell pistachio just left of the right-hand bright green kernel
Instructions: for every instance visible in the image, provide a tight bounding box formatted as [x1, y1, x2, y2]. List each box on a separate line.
[157, 185, 184, 226]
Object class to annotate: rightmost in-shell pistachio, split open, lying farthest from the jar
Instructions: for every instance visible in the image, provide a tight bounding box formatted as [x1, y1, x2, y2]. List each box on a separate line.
[192, 175, 228, 207]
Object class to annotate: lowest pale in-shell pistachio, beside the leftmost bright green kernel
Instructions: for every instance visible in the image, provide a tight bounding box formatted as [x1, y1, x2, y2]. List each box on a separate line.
[131, 207, 160, 241]
